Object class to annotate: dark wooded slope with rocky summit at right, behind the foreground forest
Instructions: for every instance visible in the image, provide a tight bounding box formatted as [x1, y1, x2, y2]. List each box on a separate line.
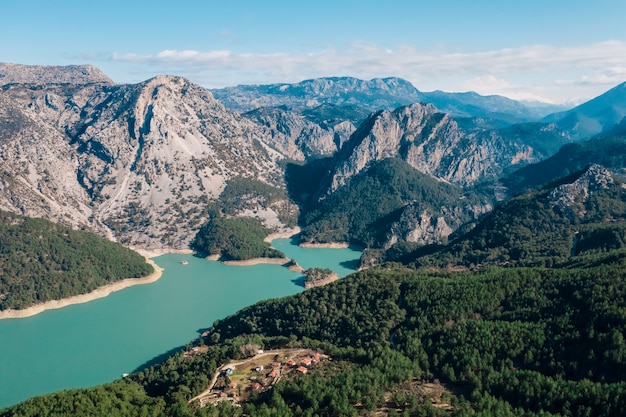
[413, 165, 626, 267]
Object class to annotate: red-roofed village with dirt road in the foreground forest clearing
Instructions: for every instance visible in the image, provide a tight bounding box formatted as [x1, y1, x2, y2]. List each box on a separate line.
[189, 347, 331, 407]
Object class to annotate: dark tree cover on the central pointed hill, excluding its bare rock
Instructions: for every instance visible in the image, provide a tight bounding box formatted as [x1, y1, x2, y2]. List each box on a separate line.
[300, 158, 478, 247]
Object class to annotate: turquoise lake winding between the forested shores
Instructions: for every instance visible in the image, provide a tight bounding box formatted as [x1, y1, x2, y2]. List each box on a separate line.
[0, 239, 361, 408]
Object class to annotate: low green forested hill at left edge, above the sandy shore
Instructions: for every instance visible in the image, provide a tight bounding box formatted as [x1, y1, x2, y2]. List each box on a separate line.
[0, 211, 154, 310]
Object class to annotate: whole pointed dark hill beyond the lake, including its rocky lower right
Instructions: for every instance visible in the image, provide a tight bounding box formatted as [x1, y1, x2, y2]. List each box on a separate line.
[300, 158, 490, 248]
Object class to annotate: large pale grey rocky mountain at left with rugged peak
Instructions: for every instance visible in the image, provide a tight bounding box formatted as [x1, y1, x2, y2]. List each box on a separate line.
[0, 68, 284, 248]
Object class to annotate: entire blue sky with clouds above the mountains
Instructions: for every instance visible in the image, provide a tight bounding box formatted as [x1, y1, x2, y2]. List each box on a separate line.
[0, 0, 626, 104]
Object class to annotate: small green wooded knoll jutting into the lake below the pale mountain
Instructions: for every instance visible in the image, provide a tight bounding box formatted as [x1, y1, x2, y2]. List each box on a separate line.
[191, 216, 284, 260]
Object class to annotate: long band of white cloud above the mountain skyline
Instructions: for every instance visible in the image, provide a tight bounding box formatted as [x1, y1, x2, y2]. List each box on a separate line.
[112, 40, 626, 102]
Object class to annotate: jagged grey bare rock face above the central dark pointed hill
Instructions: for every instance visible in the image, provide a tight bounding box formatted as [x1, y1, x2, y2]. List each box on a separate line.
[330, 103, 536, 191]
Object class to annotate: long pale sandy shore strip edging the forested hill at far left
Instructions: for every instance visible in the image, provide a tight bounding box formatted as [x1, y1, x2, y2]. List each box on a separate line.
[0, 255, 163, 320]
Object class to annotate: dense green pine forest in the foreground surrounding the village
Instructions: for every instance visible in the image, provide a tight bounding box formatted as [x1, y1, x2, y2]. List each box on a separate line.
[7, 258, 626, 417]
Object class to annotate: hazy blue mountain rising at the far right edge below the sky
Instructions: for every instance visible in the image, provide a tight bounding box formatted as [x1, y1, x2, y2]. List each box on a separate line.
[543, 82, 626, 141]
